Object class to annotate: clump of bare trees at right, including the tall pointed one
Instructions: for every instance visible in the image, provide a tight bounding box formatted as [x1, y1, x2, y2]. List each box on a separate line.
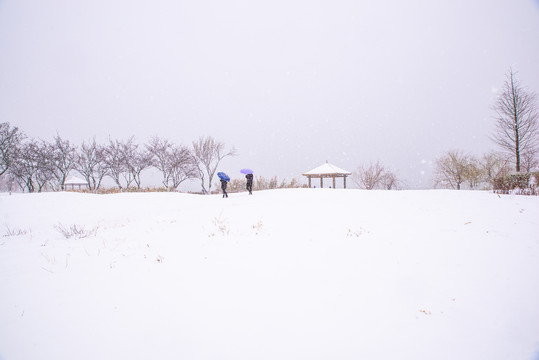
[434, 69, 539, 191]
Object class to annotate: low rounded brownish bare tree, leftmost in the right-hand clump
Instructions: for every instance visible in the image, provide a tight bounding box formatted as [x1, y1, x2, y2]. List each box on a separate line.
[434, 151, 468, 190]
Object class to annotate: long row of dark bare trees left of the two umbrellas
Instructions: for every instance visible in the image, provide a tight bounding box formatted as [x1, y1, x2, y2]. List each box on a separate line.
[0, 123, 236, 193]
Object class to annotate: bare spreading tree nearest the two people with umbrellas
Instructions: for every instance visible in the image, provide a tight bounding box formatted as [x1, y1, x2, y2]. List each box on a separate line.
[193, 136, 237, 193]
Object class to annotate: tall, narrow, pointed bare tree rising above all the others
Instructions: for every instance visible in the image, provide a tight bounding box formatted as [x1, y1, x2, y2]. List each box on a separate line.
[492, 69, 539, 172]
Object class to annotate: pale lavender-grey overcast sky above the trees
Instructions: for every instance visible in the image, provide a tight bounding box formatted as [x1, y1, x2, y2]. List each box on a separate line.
[0, 0, 539, 188]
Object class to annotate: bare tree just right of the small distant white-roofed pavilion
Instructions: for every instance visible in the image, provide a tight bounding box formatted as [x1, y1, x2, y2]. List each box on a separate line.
[76, 138, 108, 191]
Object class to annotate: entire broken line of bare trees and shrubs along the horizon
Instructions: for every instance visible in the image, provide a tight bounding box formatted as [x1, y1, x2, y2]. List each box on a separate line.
[0, 69, 539, 193]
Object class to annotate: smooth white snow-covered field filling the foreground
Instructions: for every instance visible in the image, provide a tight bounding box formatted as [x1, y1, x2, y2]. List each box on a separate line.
[0, 189, 539, 360]
